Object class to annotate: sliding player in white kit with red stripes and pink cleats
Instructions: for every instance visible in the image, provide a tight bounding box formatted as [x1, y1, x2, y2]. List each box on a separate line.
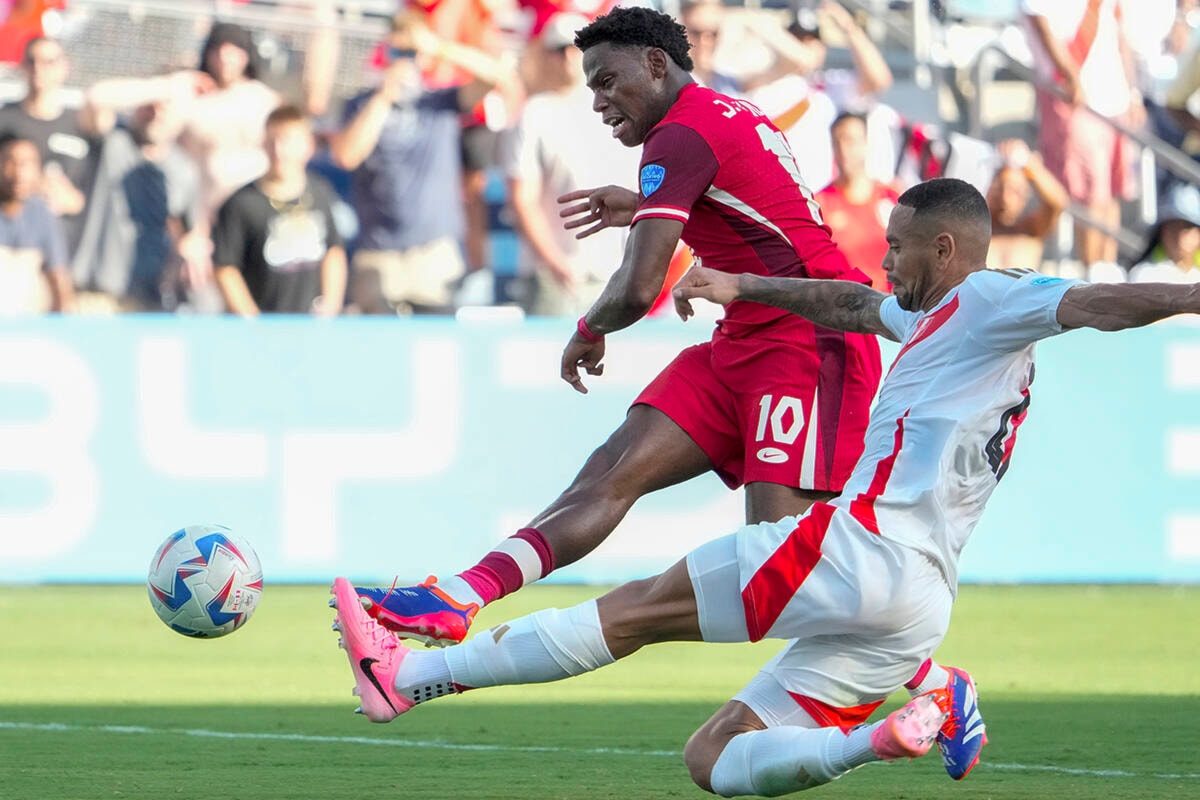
[334, 179, 1200, 796]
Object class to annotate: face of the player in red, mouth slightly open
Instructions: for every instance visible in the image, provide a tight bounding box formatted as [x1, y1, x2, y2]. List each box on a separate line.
[583, 42, 674, 148]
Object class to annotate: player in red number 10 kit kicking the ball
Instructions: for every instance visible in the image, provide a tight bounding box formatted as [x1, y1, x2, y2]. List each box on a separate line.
[356, 7, 982, 777]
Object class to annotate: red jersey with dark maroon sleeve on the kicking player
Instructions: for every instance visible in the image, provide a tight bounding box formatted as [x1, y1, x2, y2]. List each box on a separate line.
[634, 84, 870, 339]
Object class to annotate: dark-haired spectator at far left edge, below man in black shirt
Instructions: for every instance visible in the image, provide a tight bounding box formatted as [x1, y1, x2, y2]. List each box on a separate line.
[0, 136, 74, 313]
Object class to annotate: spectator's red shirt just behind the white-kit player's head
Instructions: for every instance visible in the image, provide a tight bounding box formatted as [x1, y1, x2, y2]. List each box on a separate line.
[817, 184, 900, 291]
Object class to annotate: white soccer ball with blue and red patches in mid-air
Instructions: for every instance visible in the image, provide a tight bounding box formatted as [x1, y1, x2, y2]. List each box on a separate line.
[146, 525, 263, 639]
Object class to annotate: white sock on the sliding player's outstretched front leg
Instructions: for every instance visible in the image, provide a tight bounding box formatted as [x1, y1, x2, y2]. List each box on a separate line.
[436, 600, 616, 688]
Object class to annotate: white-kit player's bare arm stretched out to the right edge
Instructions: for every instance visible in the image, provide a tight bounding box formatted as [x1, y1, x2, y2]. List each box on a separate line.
[1058, 283, 1200, 331]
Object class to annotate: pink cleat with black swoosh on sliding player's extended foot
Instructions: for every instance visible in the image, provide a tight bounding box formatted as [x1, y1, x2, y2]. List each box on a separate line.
[329, 578, 414, 722]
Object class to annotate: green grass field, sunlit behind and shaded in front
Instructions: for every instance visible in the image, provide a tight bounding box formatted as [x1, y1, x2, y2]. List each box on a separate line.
[0, 587, 1200, 800]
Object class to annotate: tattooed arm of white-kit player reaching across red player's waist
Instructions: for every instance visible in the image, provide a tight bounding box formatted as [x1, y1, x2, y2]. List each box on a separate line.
[673, 266, 896, 341]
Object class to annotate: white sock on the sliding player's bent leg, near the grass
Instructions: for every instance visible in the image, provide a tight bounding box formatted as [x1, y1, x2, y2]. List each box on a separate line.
[710, 723, 878, 798]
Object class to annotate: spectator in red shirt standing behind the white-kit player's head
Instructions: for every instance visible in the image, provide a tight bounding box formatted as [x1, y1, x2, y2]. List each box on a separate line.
[817, 112, 899, 291]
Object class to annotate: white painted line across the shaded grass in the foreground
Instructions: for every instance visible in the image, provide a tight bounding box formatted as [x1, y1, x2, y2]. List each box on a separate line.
[0, 720, 1200, 781]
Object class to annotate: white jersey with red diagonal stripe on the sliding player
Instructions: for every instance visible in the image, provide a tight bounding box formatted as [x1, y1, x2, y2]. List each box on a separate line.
[832, 270, 1078, 590]
